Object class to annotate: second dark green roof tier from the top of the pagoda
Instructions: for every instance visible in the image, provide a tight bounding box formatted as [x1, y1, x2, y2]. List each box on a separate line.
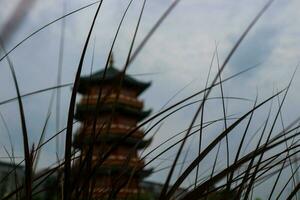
[75, 103, 151, 120]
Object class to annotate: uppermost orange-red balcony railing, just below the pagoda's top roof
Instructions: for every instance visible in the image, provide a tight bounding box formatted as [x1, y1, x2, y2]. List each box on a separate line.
[81, 94, 144, 109]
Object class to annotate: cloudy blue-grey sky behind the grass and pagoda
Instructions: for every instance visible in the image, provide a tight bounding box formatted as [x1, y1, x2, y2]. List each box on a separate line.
[0, 0, 300, 197]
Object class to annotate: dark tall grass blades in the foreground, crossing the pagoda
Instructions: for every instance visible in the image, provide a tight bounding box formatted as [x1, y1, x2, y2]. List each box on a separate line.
[0, 0, 300, 200]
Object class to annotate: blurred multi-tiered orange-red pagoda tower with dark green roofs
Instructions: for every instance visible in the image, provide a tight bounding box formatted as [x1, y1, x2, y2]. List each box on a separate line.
[74, 59, 151, 199]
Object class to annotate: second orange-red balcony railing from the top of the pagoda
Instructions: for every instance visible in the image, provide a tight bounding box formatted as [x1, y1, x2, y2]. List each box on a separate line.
[80, 124, 144, 138]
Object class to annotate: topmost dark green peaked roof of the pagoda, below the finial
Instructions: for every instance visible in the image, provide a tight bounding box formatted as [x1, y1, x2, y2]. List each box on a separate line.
[78, 66, 151, 94]
